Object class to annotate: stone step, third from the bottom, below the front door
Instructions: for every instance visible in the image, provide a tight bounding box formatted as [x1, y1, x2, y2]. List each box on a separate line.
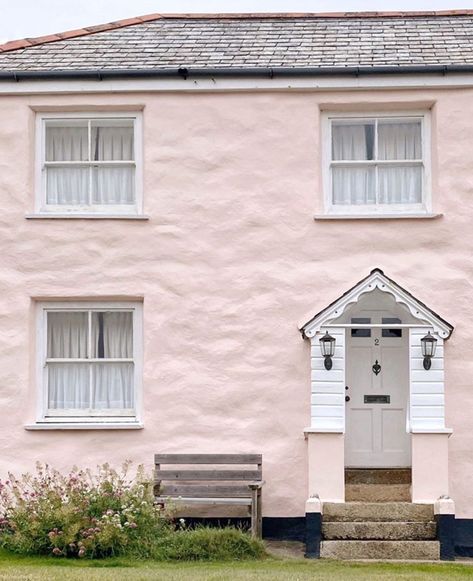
[323, 502, 434, 522]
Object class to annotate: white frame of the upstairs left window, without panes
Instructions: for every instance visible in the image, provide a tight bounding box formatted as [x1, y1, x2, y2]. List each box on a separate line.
[35, 111, 143, 217]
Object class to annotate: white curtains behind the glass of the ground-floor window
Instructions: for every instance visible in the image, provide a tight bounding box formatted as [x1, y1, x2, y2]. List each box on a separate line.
[48, 312, 134, 410]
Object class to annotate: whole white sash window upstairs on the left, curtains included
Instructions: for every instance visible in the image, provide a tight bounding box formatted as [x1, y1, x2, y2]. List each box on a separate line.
[36, 113, 141, 215]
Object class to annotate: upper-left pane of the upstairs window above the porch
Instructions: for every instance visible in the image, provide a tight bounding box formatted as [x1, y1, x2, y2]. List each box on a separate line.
[332, 122, 374, 161]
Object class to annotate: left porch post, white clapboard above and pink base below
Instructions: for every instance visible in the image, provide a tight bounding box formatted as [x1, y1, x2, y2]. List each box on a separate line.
[304, 327, 345, 502]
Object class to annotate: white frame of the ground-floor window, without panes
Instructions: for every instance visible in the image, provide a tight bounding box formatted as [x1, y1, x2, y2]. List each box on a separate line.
[36, 301, 143, 425]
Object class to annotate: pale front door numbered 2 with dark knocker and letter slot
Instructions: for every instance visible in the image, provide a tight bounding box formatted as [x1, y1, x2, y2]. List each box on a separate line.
[345, 313, 411, 468]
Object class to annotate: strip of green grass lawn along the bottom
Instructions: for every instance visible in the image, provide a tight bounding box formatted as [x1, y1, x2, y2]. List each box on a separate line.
[0, 551, 473, 581]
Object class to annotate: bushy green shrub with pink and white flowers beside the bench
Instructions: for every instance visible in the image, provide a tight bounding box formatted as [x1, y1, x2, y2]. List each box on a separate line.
[0, 462, 172, 558]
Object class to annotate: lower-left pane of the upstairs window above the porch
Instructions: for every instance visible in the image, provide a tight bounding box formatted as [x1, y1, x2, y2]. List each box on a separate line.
[332, 167, 376, 205]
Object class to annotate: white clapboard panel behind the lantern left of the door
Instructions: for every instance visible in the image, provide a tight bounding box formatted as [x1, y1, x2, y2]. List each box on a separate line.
[311, 328, 345, 433]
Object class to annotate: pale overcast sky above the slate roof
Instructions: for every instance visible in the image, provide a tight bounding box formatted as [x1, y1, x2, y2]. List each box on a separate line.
[0, 0, 473, 42]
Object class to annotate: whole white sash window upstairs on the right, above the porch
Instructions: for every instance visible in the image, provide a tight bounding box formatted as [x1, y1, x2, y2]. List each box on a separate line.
[324, 114, 431, 216]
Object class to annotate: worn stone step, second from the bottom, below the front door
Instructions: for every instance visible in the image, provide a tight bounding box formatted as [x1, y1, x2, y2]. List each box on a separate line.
[322, 522, 437, 541]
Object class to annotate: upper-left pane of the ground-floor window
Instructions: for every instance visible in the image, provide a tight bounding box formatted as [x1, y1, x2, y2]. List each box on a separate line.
[47, 312, 87, 359]
